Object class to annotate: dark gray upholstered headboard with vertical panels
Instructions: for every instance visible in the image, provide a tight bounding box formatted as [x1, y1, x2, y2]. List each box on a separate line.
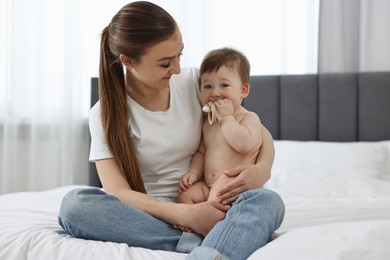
[90, 72, 390, 186]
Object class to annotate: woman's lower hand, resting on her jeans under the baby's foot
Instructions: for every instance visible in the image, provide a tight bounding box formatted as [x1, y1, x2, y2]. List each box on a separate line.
[179, 201, 230, 237]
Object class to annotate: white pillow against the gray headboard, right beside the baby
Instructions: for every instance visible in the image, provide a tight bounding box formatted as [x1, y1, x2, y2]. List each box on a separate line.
[273, 141, 387, 178]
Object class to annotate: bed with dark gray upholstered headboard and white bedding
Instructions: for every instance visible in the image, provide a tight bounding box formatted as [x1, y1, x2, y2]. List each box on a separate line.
[0, 72, 390, 260]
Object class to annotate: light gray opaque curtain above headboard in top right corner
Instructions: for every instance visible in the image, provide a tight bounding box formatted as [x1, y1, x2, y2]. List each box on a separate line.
[318, 0, 390, 73]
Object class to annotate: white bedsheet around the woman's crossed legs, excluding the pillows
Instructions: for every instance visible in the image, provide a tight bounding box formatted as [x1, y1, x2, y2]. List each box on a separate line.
[0, 182, 390, 260]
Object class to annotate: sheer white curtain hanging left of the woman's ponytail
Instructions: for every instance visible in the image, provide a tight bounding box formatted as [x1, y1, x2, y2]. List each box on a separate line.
[0, 0, 88, 193]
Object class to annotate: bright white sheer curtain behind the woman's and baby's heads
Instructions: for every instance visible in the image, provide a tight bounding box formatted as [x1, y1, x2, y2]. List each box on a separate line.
[161, 0, 319, 75]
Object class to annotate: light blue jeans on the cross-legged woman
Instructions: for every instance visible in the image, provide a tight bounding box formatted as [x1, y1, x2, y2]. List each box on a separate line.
[58, 188, 284, 260]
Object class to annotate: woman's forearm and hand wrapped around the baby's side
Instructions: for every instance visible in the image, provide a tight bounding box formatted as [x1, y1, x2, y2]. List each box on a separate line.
[213, 126, 275, 204]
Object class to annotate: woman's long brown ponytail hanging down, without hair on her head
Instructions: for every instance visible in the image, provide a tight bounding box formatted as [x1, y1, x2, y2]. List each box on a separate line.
[99, 26, 146, 193]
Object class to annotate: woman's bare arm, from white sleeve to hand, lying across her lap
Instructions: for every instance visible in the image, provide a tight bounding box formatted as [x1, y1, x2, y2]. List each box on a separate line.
[96, 159, 228, 236]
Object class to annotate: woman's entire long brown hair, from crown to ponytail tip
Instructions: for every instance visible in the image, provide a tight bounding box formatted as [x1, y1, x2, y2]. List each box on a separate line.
[99, 1, 177, 193]
